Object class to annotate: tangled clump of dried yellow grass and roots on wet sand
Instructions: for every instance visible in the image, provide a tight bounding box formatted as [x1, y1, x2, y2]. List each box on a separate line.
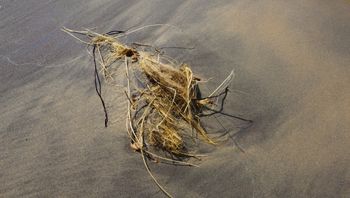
[62, 25, 251, 196]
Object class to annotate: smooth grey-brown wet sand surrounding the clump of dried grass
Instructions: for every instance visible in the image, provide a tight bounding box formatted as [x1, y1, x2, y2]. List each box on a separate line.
[0, 0, 350, 197]
